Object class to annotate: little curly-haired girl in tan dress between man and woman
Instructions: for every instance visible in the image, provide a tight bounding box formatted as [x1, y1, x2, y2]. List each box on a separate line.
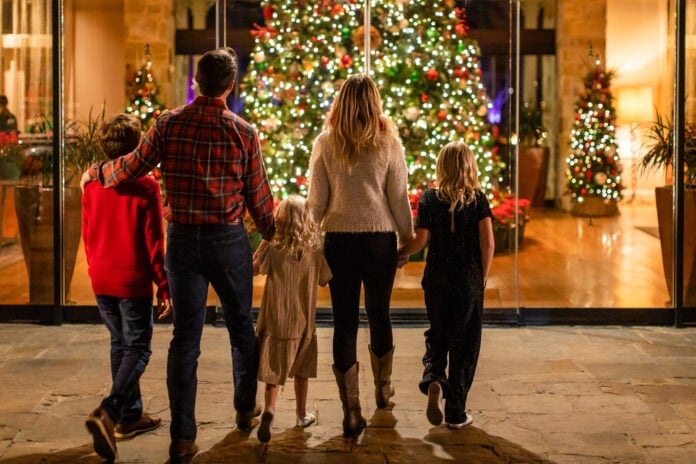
[254, 195, 332, 443]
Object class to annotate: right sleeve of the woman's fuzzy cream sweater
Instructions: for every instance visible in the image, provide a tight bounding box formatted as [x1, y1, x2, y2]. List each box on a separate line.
[385, 141, 413, 243]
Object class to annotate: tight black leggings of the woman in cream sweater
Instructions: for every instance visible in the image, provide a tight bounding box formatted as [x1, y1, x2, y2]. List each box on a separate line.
[324, 232, 396, 372]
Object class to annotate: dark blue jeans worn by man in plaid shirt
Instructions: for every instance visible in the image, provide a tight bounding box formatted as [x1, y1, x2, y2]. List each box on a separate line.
[165, 224, 259, 440]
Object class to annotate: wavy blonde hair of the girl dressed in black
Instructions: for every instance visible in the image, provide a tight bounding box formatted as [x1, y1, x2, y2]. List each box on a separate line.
[435, 142, 481, 217]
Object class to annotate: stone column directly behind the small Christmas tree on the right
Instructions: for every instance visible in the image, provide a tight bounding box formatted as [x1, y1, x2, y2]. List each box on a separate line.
[552, 0, 607, 210]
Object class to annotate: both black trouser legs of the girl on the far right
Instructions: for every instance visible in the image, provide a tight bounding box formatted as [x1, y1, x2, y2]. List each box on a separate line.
[419, 282, 483, 424]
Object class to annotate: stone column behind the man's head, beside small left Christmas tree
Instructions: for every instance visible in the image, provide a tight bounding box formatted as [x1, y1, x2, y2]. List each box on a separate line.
[123, 0, 174, 108]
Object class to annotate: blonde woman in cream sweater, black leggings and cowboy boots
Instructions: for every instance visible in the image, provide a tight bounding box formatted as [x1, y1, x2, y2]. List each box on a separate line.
[308, 74, 413, 436]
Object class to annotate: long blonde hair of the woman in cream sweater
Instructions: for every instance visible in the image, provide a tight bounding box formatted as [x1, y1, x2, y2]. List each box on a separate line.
[324, 74, 396, 165]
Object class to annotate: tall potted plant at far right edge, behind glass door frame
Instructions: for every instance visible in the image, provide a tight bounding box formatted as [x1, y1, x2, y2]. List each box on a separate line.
[640, 113, 696, 307]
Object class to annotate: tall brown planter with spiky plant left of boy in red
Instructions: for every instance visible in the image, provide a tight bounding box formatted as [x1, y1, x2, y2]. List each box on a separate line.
[15, 109, 104, 304]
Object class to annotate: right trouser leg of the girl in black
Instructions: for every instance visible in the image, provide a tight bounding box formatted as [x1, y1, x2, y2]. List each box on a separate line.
[445, 296, 483, 424]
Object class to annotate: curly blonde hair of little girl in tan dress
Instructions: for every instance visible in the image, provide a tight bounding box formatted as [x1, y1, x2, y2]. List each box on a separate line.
[271, 195, 320, 256]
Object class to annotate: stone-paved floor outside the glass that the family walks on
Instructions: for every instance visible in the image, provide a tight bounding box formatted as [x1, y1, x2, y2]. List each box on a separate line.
[0, 324, 696, 464]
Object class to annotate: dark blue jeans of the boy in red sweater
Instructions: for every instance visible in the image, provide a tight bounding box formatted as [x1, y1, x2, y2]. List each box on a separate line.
[96, 295, 152, 423]
